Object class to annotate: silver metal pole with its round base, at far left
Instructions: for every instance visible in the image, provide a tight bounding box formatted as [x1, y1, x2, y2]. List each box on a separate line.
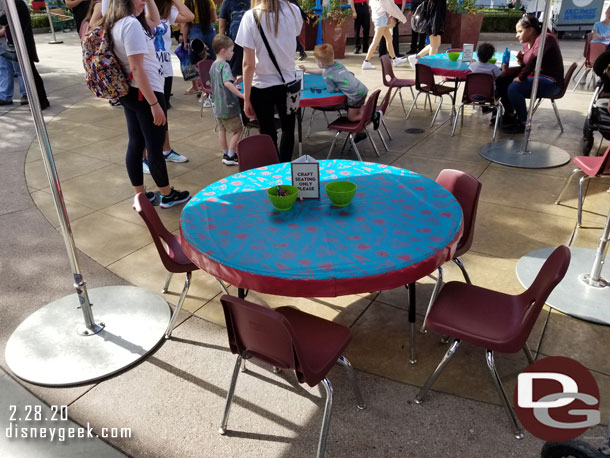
[0, 0, 170, 386]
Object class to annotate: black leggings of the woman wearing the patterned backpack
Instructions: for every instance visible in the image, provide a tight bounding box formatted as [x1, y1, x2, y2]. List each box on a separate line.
[120, 87, 169, 188]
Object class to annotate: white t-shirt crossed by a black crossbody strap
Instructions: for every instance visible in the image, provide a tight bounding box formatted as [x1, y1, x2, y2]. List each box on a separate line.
[235, 0, 303, 88]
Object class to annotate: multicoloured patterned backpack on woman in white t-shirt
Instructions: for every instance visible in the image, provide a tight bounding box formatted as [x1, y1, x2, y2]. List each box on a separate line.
[82, 26, 129, 99]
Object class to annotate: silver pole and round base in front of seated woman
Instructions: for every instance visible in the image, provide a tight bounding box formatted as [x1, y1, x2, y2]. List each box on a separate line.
[481, 0, 570, 169]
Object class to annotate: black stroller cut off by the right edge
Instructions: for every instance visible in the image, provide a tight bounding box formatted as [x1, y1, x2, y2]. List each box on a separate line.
[582, 50, 610, 156]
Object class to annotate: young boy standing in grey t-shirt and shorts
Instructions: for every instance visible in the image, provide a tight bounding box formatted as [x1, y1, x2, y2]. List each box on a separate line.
[210, 35, 243, 165]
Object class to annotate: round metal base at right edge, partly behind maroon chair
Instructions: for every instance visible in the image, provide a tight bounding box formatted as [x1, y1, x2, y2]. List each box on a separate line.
[517, 247, 610, 325]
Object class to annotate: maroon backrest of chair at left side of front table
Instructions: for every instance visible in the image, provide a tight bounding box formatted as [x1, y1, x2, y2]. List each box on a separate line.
[133, 192, 198, 273]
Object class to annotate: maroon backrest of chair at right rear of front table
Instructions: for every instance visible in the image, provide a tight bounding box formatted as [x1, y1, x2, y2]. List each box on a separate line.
[436, 169, 481, 258]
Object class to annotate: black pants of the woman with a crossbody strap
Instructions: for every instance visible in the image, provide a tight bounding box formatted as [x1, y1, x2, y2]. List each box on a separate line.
[250, 84, 296, 162]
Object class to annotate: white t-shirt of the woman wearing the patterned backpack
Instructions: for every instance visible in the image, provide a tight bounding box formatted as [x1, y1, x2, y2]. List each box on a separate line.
[112, 16, 165, 92]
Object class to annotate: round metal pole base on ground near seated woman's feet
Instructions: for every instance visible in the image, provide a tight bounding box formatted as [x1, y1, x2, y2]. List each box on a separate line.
[480, 140, 570, 169]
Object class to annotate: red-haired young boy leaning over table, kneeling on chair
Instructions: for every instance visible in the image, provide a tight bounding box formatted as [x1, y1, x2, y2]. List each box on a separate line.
[300, 44, 368, 121]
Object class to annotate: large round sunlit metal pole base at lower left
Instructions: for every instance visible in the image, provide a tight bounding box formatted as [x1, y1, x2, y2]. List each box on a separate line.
[5, 286, 171, 386]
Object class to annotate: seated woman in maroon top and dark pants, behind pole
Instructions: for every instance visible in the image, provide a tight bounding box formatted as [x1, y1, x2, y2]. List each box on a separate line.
[496, 16, 564, 134]
